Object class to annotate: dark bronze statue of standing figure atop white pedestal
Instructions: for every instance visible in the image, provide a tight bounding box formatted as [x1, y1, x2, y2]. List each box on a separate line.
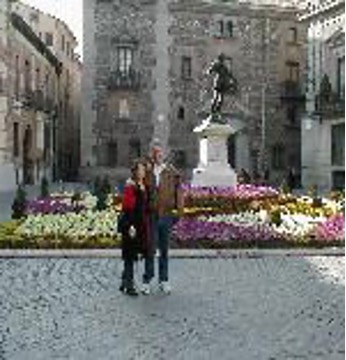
[208, 54, 237, 122]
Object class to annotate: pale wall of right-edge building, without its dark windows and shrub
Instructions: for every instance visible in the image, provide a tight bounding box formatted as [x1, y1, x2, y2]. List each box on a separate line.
[301, 1, 345, 191]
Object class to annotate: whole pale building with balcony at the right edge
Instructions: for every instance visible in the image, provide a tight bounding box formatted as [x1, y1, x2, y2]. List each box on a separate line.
[300, 0, 345, 191]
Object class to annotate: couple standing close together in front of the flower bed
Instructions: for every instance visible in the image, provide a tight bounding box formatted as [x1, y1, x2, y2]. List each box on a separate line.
[119, 144, 183, 296]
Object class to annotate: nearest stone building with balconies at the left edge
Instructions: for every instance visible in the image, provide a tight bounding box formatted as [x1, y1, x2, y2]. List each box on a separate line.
[0, 2, 61, 190]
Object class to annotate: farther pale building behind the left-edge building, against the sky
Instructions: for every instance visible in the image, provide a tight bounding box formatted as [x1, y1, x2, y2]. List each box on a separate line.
[13, 2, 82, 180]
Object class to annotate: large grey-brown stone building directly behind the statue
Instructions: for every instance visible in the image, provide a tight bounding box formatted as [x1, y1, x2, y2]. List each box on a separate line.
[81, 0, 305, 183]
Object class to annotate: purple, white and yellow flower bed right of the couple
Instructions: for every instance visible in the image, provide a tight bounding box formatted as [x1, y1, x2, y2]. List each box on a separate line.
[172, 185, 344, 248]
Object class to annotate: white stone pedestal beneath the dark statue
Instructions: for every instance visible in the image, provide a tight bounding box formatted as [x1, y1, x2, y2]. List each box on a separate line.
[192, 120, 237, 186]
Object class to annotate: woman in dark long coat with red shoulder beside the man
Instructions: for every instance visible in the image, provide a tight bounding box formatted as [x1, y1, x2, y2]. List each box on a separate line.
[120, 161, 149, 296]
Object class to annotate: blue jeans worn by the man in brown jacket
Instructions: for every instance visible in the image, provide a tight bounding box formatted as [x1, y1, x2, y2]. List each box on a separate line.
[143, 216, 173, 284]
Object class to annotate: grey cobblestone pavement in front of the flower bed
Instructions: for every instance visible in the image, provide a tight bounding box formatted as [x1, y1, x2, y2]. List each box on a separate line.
[0, 256, 345, 360]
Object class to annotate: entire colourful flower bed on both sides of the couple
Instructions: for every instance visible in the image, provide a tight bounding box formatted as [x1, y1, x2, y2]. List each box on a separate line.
[0, 185, 345, 248]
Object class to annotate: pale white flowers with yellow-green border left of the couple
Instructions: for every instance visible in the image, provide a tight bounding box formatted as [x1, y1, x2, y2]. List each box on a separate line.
[0, 210, 120, 248]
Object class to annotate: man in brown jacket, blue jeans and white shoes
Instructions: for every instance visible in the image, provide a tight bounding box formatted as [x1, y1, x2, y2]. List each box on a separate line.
[142, 142, 183, 295]
